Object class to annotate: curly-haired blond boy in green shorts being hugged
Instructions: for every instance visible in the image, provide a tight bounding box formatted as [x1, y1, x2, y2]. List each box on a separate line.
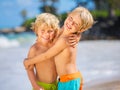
[27, 13, 59, 90]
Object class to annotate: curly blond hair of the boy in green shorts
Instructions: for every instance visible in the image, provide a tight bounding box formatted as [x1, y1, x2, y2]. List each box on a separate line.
[31, 13, 60, 35]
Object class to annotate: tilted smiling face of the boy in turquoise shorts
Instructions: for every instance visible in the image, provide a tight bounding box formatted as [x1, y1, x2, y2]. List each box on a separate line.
[64, 12, 81, 33]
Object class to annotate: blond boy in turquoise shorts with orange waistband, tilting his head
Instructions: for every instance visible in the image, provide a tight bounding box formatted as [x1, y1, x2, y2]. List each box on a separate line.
[24, 7, 94, 90]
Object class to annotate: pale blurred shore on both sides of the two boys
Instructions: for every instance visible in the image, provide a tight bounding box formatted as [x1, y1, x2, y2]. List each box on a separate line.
[0, 40, 120, 90]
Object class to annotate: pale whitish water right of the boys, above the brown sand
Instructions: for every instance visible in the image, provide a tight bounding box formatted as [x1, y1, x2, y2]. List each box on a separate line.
[77, 40, 120, 85]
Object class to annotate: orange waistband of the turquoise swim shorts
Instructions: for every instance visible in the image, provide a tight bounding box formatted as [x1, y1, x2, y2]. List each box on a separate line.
[60, 72, 82, 82]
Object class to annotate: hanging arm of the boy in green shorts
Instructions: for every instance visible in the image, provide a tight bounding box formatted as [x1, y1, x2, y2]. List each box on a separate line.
[24, 47, 41, 90]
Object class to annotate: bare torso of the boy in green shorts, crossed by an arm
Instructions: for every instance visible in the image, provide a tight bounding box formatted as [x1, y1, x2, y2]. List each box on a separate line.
[35, 44, 57, 83]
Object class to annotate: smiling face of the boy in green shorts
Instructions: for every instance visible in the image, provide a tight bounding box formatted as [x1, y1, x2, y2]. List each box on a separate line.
[37, 24, 55, 43]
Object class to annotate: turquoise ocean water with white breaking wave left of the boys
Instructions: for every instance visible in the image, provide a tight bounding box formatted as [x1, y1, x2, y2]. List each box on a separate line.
[0, 32, 36, 48]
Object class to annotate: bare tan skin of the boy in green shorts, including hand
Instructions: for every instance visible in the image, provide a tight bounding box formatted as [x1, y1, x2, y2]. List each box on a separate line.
[27, 22, 79, 90]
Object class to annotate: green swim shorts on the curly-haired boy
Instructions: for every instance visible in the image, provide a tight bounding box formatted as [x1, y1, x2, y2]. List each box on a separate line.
[33, 81, 58, 90]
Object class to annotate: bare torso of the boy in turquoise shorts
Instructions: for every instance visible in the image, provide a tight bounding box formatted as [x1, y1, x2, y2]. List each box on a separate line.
[55, 47, 78, 76]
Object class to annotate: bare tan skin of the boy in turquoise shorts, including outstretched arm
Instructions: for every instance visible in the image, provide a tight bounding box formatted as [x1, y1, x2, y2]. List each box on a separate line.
[24, 13, 82, 76]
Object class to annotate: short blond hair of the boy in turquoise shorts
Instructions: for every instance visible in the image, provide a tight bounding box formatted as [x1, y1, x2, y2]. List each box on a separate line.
[70, 6, 94, 31]
